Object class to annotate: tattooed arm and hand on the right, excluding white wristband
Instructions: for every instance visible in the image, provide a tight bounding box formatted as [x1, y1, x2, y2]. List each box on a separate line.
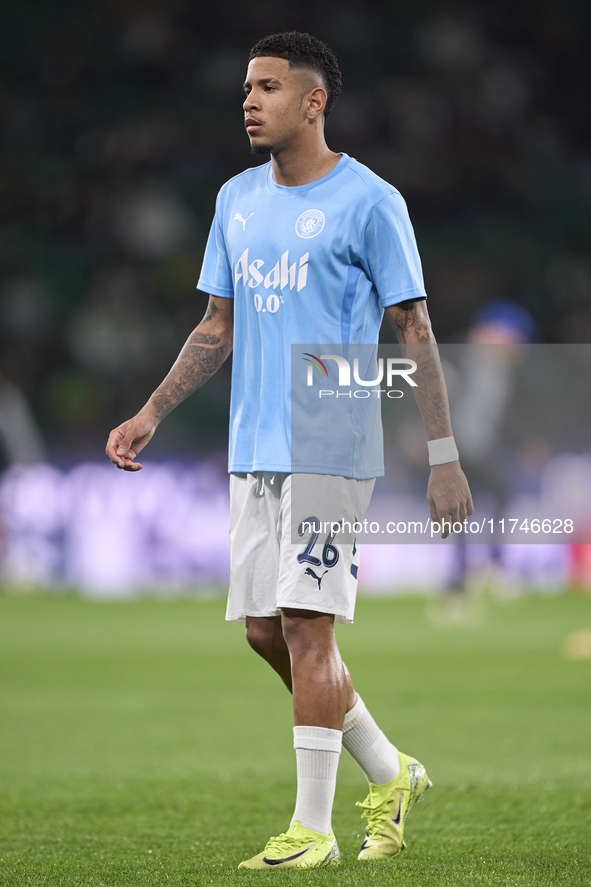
[386, 300, 474, 539]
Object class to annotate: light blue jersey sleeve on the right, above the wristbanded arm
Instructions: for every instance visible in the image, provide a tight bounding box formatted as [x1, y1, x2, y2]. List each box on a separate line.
[365, 191, 427, 308]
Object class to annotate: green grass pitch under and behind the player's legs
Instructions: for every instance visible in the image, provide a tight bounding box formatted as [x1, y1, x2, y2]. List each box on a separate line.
[0, 595, 591, 887]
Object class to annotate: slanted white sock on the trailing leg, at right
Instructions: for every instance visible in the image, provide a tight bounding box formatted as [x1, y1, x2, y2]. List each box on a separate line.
[343, 696, 400, 785]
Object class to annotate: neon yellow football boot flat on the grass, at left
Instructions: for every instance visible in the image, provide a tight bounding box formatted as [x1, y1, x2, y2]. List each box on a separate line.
[238, 822, 340, 869]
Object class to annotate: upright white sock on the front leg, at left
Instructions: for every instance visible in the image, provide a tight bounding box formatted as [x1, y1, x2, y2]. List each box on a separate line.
[291, 727, 343, 835]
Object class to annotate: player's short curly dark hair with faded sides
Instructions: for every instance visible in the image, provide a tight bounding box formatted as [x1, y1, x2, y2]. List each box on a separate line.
[248, 31, 342, 117]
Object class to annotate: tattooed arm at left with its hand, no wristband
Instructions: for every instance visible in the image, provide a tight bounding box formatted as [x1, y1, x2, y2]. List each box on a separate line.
[106, 296, 234, 471]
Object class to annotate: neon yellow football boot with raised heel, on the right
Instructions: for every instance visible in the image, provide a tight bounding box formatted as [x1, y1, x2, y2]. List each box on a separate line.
[357, 752, 433, 859]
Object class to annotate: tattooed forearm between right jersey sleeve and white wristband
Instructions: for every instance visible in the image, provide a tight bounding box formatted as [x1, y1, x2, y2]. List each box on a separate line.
[386, 301, 452, 440]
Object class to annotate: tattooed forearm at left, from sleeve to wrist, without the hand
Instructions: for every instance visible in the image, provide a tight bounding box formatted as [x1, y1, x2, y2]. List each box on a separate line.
[150, 298, 232, 421]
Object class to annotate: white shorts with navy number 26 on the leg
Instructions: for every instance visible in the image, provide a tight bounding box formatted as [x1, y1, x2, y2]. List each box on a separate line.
[226, 471, 375, 622]
